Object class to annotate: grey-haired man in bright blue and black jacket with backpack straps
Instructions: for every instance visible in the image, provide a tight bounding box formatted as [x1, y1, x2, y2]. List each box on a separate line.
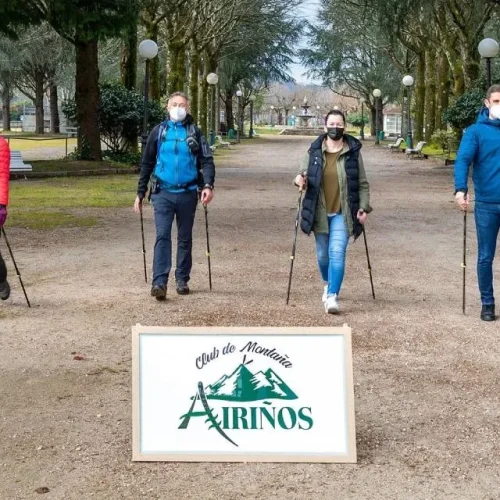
[134, 92, 215, 300]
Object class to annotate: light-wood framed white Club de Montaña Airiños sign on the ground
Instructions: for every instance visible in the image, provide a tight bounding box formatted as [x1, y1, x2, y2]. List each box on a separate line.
[132, 325, 356, 462]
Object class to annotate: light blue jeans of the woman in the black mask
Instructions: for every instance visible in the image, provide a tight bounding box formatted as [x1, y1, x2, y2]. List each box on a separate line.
[314, 212, 349, 295]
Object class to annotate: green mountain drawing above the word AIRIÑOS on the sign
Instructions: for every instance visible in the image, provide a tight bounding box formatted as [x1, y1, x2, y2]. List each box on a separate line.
[205, 363, 297, 402]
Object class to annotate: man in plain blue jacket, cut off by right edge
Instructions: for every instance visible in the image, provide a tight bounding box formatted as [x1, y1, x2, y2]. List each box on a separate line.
[455, 85, 500, 321]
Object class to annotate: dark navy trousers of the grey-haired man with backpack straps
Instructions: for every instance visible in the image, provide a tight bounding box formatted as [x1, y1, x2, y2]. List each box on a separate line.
[151, 190, 198, 285]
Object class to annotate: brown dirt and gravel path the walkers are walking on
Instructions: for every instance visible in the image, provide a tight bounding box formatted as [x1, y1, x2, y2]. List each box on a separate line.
[0, 137, 500, 500]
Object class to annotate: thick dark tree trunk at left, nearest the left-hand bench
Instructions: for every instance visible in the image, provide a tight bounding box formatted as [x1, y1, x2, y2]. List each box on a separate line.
[75, 39, 102, 160]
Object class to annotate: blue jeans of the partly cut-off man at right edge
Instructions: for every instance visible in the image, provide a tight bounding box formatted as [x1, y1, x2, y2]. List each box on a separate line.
[474, 201, 500, 305]
